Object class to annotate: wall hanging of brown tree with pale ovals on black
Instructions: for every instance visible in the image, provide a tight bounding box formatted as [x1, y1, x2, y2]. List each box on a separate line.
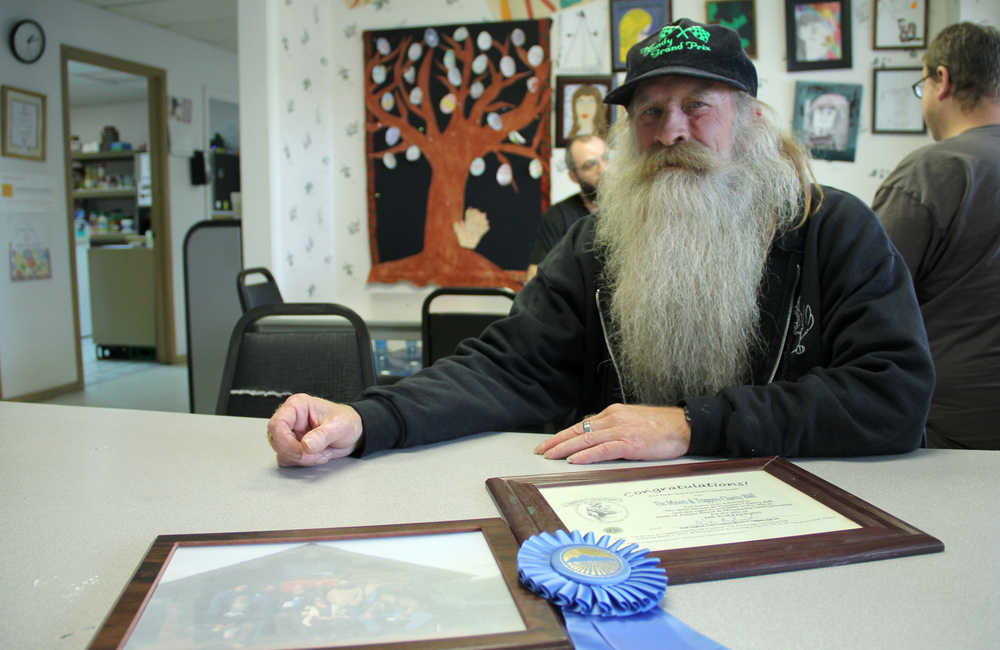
[364, 19, 551, 289]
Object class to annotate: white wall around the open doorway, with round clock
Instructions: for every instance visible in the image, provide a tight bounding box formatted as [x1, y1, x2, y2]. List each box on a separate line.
[0, 0, 237, 398]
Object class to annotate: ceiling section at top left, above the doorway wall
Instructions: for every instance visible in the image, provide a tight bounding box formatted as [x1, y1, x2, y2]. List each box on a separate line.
[79, 0, 238, 54]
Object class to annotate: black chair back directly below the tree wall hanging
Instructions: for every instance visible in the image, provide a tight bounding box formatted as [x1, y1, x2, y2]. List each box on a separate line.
[420, 287, 515, 367]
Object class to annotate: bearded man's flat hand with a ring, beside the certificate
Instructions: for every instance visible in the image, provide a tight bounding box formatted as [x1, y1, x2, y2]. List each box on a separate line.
[535, 404, 691, 464]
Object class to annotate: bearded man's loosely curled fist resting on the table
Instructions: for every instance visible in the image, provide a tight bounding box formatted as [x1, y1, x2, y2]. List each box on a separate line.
[267, 393, 361, 467]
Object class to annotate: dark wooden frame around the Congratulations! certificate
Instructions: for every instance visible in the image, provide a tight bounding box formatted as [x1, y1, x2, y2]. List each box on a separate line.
[486, 457, 944, 585]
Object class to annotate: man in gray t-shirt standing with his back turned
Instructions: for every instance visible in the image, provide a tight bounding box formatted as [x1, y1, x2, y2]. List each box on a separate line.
[872, 23, 1000, 449]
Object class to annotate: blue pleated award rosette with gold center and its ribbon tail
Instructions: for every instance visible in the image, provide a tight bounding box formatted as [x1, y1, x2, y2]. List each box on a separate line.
[517, 530, 724, 650]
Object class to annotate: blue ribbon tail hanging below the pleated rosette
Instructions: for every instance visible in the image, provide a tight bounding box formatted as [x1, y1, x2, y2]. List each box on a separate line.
[563, 607, 726, 650]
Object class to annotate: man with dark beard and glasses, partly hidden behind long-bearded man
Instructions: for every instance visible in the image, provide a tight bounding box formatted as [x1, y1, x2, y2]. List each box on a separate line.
[525, 135, 608, 280]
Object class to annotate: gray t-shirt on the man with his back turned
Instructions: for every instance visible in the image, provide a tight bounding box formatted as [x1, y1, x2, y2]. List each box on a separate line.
[872, 125, 1000, 449]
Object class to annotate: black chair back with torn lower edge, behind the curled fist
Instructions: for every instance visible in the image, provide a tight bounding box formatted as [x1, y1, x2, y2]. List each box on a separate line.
[215, 302, 375, 417]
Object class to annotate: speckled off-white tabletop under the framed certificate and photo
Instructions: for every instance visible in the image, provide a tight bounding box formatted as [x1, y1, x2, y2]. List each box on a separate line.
[0, 402, 1000, 649]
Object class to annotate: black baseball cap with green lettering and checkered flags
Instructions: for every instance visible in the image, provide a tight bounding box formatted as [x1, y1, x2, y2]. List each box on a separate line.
[604, 18, 757, 106]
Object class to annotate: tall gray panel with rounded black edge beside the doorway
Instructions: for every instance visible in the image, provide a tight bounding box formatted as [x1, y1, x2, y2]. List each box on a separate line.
[184, 219, 243, 413]
